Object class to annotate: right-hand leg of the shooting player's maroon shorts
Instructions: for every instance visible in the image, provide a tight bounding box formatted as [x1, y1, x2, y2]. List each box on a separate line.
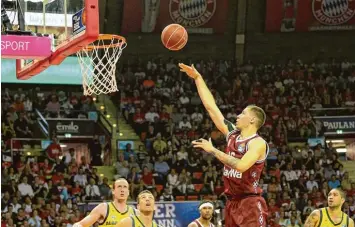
[239, 196, 268, 227]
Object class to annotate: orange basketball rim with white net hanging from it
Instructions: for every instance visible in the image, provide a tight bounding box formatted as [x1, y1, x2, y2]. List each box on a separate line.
[77, 34, 127, 95]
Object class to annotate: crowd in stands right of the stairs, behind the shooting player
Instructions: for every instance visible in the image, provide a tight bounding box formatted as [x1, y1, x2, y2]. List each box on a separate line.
[116, 59, 355, 227]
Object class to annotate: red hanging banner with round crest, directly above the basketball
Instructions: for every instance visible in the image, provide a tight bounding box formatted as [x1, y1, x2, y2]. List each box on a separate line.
[121, 0, 229, 34]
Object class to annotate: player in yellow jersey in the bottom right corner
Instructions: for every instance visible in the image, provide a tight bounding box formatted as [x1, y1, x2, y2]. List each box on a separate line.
[304, 188, 354, 227]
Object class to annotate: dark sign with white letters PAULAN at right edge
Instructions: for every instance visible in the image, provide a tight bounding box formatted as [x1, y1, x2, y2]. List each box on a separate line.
[314, 116, 355, 135]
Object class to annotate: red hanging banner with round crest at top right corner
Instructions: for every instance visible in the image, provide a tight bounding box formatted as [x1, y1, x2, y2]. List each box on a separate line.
[265, 0, 355, 32]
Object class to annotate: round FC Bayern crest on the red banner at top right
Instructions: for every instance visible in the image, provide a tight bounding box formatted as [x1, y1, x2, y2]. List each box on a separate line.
[312, 0, 355, 25]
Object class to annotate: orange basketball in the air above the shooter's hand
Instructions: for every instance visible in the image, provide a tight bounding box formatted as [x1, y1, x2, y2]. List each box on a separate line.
[161, 24, 188, 51]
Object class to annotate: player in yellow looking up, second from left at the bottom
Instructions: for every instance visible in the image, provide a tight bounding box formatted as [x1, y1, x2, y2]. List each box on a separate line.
[116, 190, 158, 227]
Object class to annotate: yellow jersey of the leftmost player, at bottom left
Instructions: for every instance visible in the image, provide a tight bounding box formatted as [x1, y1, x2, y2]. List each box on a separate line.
[99, 202, 136, 227]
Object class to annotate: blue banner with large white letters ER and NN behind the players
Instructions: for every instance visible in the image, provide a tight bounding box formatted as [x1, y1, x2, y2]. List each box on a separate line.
[87, 201, 200, 227]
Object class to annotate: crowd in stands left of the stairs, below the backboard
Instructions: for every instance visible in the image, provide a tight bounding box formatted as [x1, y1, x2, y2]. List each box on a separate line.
[1, 88, 103, 227]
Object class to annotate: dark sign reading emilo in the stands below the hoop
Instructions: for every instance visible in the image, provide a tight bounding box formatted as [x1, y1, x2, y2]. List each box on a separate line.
[46, 119, 95, 137]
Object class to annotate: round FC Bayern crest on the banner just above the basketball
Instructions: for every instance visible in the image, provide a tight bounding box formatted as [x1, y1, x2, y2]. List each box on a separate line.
[169, 0, 216, 27]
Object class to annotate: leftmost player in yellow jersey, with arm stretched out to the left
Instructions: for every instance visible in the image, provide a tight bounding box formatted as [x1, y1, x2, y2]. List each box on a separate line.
[73, 178, 137, 227]
